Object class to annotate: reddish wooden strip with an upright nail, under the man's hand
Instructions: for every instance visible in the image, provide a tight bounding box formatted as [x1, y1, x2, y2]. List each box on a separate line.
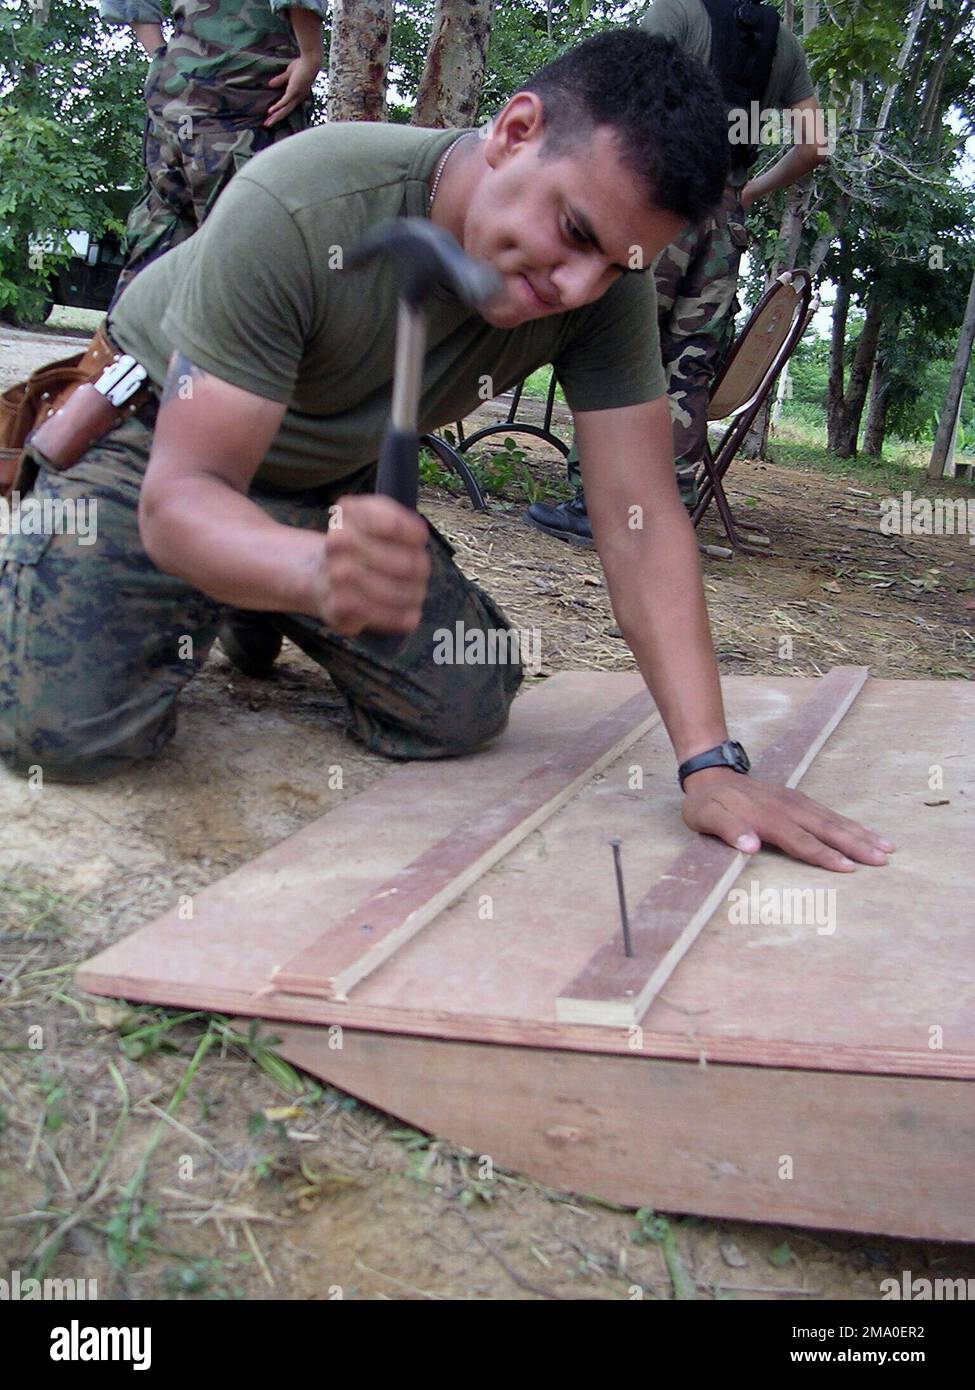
[555, 666, 868, 1027]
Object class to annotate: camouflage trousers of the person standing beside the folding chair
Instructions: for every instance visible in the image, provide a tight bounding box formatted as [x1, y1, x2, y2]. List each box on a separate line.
[569, 188, 748, 492]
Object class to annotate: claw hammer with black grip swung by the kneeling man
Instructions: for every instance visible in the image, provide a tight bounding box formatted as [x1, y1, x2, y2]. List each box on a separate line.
[346, 217, 502, 507]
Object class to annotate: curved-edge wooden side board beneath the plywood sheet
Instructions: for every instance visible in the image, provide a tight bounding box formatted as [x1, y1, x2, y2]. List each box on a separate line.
[262, 1023, 975, 1245]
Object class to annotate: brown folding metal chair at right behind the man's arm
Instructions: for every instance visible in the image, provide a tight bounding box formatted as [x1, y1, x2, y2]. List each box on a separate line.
[691, 270, 819, 550]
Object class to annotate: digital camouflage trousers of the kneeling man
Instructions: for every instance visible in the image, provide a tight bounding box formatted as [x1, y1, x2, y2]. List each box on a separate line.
[0, 417, 523, 781]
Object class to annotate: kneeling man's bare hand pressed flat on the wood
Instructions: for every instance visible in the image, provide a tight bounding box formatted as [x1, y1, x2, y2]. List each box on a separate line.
[683, 767, 894, 873]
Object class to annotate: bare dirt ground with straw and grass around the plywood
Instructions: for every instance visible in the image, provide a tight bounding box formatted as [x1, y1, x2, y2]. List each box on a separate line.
[0, 329, 975, 1301]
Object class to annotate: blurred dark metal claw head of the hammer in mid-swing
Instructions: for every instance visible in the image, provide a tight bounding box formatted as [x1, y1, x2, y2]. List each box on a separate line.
[346, 217, 503, 309]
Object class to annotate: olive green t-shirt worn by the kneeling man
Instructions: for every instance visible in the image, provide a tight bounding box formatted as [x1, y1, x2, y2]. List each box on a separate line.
[110, 122, 666, 488]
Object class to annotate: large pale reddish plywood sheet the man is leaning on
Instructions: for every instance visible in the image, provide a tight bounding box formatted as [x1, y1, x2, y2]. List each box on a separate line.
[81, 673, 975, 1077]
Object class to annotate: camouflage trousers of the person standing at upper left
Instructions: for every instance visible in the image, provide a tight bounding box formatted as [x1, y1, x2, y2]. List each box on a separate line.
[113, 103, 307, 306]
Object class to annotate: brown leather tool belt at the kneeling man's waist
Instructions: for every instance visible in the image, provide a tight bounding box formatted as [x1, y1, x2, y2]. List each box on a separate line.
[0, 325, 153, 496]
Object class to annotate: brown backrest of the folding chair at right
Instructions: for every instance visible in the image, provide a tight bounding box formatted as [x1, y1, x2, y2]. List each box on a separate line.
[708, 270, 812, 420]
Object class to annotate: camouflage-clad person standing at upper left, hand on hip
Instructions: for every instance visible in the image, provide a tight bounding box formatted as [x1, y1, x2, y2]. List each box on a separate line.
[99, 0, 325, 307]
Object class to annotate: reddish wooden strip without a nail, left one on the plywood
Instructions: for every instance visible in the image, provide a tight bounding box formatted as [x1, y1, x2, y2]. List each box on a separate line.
[271, 692, 661, 1001]
